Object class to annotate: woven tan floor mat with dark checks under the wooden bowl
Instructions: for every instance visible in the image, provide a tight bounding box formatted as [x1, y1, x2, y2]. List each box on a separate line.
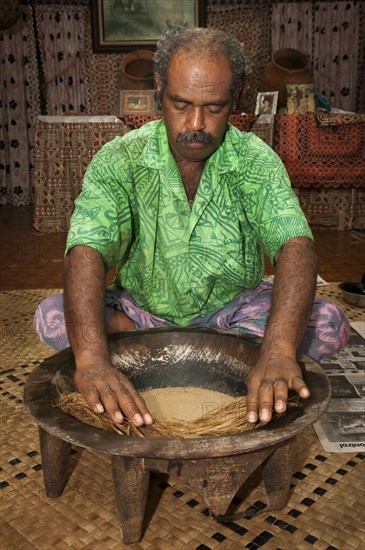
[0, 292, 365, 550]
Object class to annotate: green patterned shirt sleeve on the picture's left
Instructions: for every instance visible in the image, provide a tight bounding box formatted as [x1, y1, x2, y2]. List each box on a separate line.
[66, 137, 130, 270]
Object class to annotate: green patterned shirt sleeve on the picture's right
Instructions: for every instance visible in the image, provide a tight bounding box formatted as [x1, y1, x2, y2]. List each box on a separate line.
[239, 138, 313, 264]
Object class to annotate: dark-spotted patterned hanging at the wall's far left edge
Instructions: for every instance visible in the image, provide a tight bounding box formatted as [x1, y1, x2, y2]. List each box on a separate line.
[0, 6, 40, 206]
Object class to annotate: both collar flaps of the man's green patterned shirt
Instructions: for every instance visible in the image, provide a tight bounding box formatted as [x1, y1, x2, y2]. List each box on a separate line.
[140, 120, 238, 174]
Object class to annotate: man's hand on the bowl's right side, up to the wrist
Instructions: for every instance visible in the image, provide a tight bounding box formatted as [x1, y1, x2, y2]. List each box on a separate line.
[246, 352, 309, 423]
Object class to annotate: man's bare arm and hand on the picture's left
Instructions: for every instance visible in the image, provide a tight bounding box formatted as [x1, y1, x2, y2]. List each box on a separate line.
[64, 246, 152, 426]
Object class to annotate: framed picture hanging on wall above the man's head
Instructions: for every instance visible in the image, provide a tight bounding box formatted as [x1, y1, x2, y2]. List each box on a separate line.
[91, 0, 207, 53]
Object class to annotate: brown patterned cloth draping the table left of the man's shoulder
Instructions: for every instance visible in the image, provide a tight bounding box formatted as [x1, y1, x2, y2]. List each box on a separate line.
[33, 116, 129, 233]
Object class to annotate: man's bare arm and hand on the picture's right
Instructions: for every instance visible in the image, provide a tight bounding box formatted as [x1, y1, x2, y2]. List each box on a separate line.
[247, 237, 318, 422]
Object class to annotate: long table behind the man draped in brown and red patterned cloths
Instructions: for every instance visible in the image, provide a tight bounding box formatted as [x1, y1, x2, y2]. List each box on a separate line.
[34, 114, 365, 233]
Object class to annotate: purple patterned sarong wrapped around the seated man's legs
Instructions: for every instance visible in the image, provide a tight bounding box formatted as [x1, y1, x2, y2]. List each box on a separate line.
[34, 283, 350, 361]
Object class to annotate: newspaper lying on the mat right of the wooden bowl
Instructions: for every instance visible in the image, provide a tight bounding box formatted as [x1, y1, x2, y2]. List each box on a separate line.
[314, 323, 365, 453]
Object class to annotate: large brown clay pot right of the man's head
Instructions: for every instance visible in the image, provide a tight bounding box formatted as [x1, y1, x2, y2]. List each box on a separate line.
[259, 48, 313, 108]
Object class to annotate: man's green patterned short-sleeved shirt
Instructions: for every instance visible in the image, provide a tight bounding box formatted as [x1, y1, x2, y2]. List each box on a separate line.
[67, 121, 312, 325]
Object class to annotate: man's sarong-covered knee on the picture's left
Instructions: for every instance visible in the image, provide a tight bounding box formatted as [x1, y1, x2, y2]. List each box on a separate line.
[34, 294, 69, 351]
